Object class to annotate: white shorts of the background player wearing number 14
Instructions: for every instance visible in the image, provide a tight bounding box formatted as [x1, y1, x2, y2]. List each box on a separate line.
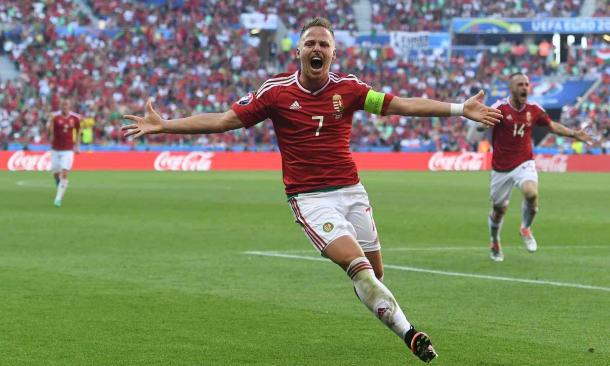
[490, 160, 538, 207]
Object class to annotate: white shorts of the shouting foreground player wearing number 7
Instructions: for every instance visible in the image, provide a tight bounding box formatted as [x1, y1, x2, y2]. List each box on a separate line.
[288, 183, 381, 254]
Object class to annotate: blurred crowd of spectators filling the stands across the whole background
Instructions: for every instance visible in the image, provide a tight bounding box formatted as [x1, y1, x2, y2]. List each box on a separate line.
[0, 0, 610, 151]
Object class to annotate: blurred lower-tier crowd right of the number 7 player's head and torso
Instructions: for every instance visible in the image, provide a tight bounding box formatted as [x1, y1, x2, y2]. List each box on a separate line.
[338, 40, 610, 151]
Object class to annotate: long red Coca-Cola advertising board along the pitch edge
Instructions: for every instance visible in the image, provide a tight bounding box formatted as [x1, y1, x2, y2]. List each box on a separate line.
[0, 151, 610, 173]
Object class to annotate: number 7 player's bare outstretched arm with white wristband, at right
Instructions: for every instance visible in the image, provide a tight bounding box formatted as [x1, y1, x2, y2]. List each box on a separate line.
[387, 91, 502, 126]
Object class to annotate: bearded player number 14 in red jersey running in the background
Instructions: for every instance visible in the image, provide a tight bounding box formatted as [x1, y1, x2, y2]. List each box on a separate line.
[488, 73, 591, 262]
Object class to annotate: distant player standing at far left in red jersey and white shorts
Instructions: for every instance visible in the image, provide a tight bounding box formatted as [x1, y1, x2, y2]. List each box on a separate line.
[49, 100, 81, 207]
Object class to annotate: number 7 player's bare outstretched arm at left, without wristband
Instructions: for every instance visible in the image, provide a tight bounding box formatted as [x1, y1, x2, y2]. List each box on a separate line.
[121, 100, 244, 137]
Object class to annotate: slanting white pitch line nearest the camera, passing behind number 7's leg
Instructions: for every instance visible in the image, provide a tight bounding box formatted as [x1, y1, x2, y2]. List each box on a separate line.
[244, 251, 610, 292]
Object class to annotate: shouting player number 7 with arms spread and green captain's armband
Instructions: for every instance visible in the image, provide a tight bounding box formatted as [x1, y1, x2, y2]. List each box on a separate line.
[123, 18, 501, 362]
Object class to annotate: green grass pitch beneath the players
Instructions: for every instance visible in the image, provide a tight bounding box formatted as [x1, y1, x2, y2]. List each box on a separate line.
[0, 172, 610, 366]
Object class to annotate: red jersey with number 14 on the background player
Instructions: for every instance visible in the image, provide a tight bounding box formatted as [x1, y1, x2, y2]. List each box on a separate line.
[491, 98, 552, 172]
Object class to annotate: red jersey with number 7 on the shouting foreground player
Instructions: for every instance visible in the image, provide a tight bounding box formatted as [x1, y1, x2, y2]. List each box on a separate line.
[232, 71, 393, 195]
